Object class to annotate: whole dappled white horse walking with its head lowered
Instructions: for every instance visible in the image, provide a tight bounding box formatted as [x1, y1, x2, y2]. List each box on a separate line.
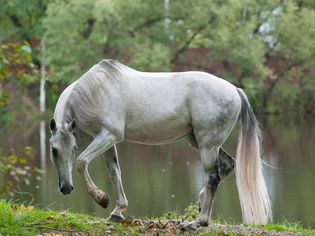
[50, 60, 272, 226]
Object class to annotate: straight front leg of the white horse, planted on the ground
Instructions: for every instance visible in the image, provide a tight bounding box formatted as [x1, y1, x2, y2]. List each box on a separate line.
[104, 145, 128, 221]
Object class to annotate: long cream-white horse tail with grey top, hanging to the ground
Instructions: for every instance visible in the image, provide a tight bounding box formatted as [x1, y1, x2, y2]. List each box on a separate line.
[235, 89, 272, 225]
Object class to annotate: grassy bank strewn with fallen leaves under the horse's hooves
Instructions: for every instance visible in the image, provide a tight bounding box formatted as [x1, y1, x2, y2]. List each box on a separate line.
[0, 200, 315, 236]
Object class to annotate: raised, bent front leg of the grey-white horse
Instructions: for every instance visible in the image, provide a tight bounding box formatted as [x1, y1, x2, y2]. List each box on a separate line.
[76, 129, 118, 208]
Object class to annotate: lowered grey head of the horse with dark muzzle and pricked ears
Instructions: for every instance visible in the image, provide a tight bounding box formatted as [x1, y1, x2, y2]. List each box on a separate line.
[49, 119, 78, 194]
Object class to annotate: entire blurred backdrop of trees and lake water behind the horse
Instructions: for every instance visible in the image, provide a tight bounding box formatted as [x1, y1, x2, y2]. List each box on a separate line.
[0, 0, 315, 227]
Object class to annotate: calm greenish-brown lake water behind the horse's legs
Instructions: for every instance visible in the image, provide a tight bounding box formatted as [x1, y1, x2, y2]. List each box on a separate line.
[0, 116, 315, 227]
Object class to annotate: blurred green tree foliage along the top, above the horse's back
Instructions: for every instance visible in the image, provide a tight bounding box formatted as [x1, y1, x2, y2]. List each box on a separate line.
[0, 0, 315, 112]
